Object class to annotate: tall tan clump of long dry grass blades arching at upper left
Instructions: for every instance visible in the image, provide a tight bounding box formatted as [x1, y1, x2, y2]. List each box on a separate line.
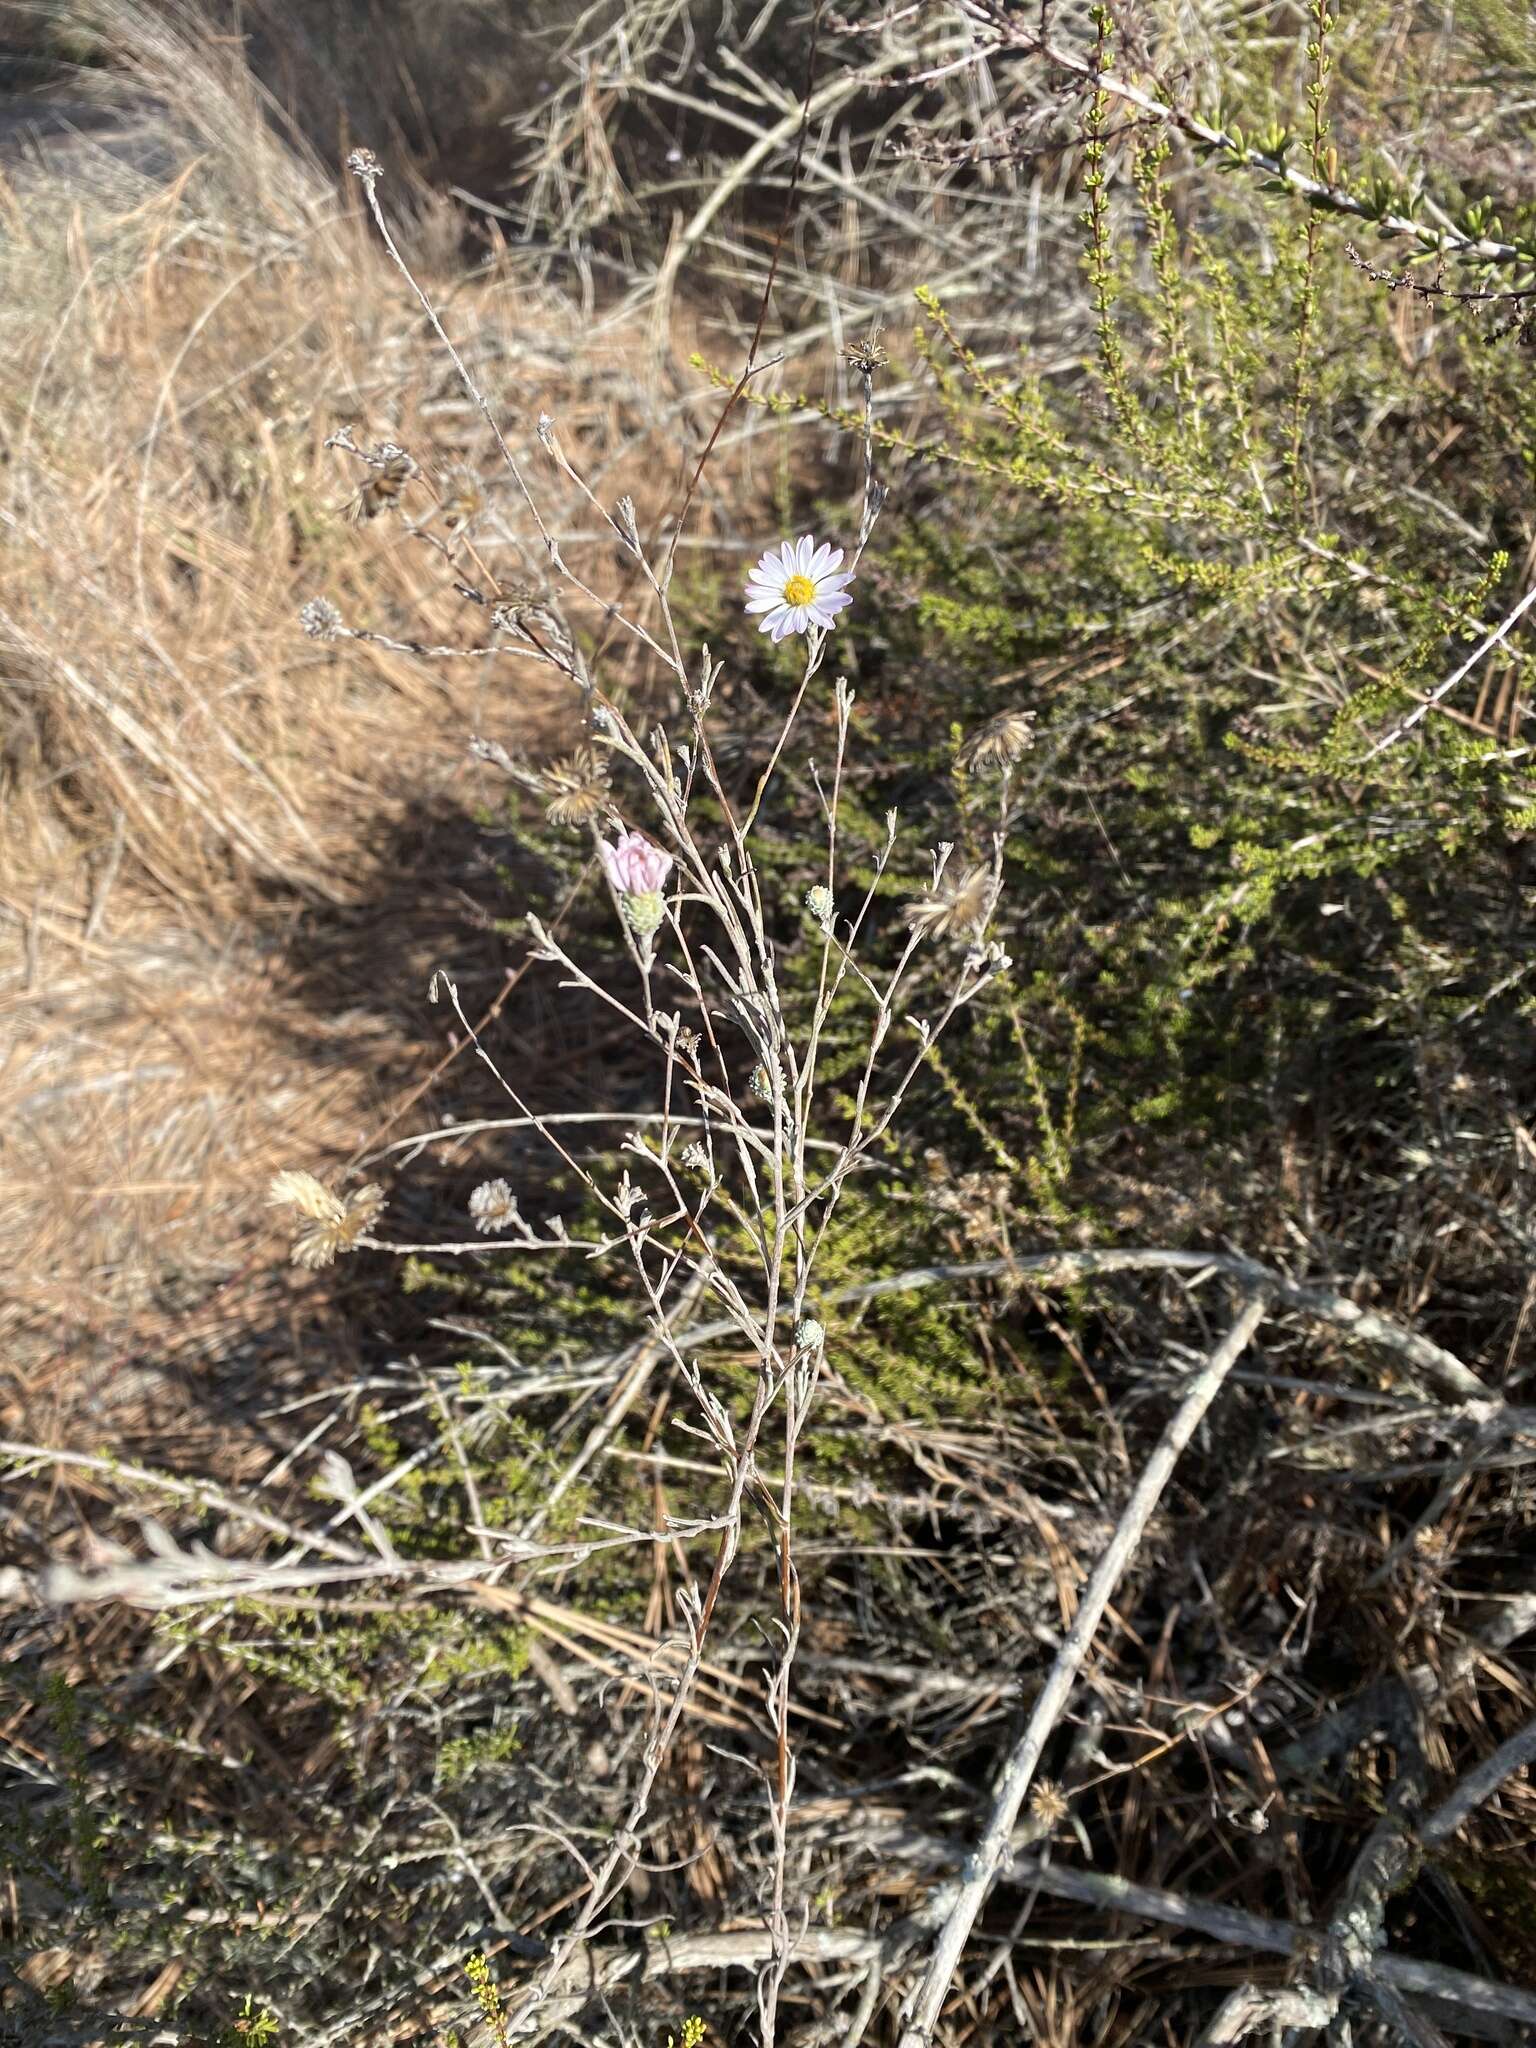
[4, 8, 487, 901]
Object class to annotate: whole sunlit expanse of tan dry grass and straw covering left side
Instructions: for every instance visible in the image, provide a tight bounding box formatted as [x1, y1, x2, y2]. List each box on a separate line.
[0, 10, 753, 1376]
